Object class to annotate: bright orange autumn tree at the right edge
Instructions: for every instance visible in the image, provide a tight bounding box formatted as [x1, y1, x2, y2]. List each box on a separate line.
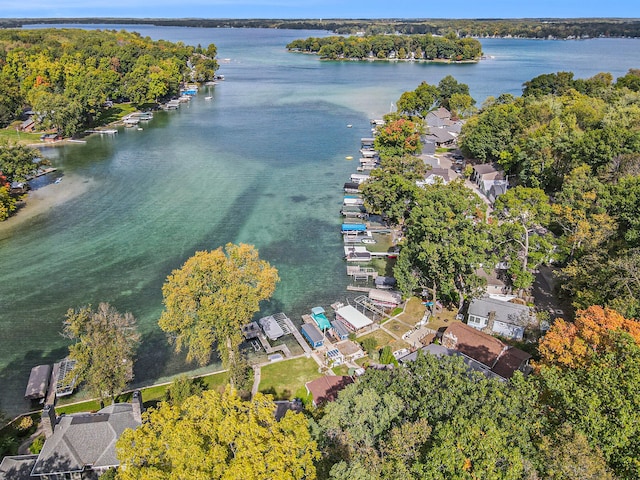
[538, 305, 640, 368]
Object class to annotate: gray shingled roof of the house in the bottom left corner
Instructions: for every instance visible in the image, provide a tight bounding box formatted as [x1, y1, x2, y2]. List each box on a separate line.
[33, 403, 140, 475]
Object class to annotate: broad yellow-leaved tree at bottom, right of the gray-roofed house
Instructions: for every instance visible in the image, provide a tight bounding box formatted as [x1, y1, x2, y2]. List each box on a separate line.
[116, 388, 318, 480]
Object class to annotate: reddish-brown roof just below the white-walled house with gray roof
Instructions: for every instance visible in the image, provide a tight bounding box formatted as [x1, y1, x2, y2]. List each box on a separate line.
[442, 322, 506, 368]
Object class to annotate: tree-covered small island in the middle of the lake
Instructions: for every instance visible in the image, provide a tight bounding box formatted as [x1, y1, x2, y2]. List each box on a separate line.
[287, 33, 482, 61]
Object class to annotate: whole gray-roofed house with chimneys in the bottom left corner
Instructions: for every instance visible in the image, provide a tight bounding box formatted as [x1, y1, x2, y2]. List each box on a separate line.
[0, 391, 143, 480]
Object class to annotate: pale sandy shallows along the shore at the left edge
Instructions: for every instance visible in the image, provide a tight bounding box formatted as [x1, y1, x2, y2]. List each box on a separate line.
[0, 175, 95, 235]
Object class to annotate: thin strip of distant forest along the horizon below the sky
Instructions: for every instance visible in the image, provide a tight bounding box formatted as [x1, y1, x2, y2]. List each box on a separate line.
[0, 18, 640, 39]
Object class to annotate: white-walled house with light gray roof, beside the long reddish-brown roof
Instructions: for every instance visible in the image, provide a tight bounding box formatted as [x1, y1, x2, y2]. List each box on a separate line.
[467, 297, 537, 340]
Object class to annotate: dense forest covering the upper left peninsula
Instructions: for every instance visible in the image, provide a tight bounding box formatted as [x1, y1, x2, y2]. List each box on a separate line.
[0, 29, 217, 136]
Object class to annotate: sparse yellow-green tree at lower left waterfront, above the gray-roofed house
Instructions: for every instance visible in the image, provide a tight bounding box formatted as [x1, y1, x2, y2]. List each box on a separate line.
[63, 303, 140, 400]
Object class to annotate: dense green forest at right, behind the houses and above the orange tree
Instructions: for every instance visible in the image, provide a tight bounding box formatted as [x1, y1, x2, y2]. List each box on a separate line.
[460, 70, 640, 318]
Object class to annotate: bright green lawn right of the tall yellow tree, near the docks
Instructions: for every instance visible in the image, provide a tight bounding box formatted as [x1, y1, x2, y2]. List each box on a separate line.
[258, 357, 322, 400]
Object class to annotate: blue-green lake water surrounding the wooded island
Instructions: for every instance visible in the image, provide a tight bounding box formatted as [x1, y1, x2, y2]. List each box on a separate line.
[0, 26, 640, 413]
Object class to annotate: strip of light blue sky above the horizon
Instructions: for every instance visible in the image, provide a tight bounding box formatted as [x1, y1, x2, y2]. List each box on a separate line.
[0, 0, 640, 19]
